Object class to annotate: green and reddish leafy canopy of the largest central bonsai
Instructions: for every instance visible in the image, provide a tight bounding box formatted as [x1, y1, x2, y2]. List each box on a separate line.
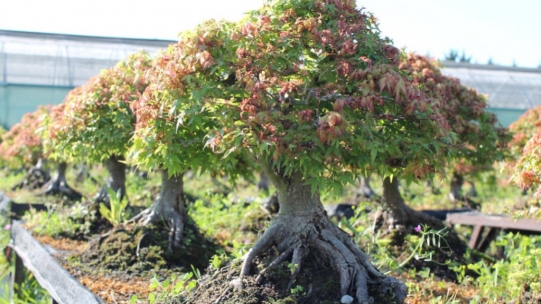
[201, 0, 453, 189]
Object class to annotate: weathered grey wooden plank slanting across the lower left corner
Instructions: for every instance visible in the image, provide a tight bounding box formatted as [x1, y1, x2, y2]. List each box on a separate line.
[10, 221, 103, 304]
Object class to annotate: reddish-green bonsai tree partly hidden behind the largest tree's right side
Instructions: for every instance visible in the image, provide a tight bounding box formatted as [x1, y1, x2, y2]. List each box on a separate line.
[390, 53, 509, 211]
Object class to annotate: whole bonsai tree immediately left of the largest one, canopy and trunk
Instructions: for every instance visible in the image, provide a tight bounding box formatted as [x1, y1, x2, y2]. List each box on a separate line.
[129, 22, 235, 249]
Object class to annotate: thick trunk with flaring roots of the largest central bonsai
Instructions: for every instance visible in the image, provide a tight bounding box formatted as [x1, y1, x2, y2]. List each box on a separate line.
[236, 167, 407, 303]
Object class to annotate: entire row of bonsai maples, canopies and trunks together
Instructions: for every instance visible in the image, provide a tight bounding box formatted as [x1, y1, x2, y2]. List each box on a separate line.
[0, 0, 541, 303]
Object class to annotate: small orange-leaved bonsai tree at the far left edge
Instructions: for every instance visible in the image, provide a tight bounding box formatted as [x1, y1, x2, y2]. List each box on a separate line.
[0, 106, 51, 189]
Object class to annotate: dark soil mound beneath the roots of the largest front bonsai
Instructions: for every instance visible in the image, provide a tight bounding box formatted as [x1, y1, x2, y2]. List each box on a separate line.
[186, 248, 400, 304]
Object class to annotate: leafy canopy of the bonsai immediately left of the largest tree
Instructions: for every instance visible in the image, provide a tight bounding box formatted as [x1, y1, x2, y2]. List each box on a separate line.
[128, 21, 234, 175]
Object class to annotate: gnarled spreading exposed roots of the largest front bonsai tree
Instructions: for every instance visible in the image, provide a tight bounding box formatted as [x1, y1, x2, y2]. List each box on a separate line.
[234, 214, 407, 303]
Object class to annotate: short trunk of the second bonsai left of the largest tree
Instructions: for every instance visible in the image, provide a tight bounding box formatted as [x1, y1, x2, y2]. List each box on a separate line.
[94, 155, 126, 206]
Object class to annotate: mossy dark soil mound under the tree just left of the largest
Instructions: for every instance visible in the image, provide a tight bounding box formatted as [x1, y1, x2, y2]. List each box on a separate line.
[75, 219, 220, 276]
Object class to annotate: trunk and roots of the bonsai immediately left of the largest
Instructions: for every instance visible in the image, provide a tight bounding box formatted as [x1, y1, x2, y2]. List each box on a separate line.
[130, 170, 187, 250]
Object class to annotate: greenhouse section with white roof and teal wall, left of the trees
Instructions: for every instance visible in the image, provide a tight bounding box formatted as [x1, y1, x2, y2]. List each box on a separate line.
[0, 30, 174, 128]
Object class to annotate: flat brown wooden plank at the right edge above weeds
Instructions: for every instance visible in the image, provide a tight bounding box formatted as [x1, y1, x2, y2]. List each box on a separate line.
[447, 212, 541, 232]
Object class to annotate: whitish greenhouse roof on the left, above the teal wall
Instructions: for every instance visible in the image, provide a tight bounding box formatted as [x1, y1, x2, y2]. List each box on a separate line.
[0, 30, 175, 87]
